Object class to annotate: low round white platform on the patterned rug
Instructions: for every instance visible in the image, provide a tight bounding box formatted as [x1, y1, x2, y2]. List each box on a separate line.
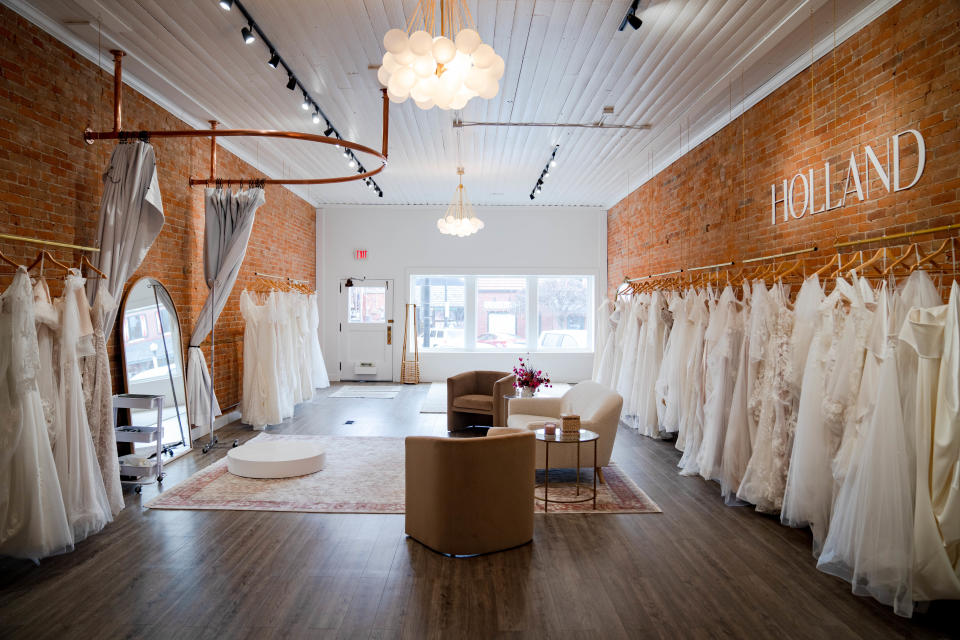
[227, 440, 326, 478]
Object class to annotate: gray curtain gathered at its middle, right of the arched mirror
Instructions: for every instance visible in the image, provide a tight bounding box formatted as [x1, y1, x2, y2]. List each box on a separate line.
[187, 189, 266, 426]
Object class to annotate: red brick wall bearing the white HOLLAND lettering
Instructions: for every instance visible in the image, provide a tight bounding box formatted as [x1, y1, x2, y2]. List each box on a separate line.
[607, 0, 960, 293]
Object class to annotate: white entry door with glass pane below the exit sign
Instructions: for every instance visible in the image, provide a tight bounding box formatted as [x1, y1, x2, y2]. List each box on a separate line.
[340, 279, 396, 381]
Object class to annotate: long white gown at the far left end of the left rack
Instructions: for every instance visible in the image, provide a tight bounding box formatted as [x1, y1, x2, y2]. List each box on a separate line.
[0, 267, 73, 561]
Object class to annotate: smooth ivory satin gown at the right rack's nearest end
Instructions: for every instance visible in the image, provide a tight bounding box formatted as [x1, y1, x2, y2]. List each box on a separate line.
[900, 287, 960, 600]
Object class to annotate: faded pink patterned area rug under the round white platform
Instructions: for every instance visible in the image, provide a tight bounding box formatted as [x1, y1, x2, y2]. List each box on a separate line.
[145, 433, 660, 515]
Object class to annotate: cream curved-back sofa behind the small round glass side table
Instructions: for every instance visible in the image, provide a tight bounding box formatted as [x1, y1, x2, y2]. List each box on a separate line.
[491, 380, 623, 479]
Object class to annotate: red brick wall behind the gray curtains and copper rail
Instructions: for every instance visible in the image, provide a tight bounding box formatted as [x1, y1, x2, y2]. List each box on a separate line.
[0, 7, 316, 407]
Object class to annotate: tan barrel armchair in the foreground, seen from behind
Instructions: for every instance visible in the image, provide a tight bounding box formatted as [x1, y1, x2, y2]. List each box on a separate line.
[405, 431, 536, 555]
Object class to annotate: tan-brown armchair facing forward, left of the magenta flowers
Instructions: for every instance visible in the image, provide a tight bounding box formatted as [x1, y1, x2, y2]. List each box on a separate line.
[447, 371, 516, 431]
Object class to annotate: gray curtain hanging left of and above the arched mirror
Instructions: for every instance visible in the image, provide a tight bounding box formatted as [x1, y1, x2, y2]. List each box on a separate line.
[87, 141, 163, 336]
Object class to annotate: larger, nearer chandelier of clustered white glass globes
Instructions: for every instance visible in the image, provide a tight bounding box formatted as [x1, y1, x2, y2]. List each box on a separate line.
[377, 0, 504, 110]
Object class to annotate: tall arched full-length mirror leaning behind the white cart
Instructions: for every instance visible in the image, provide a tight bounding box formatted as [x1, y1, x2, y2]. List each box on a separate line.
[122, 278, 190, 455]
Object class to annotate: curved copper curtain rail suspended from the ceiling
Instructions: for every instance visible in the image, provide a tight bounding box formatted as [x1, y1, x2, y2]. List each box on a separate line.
[83, 49, 390, 186]
